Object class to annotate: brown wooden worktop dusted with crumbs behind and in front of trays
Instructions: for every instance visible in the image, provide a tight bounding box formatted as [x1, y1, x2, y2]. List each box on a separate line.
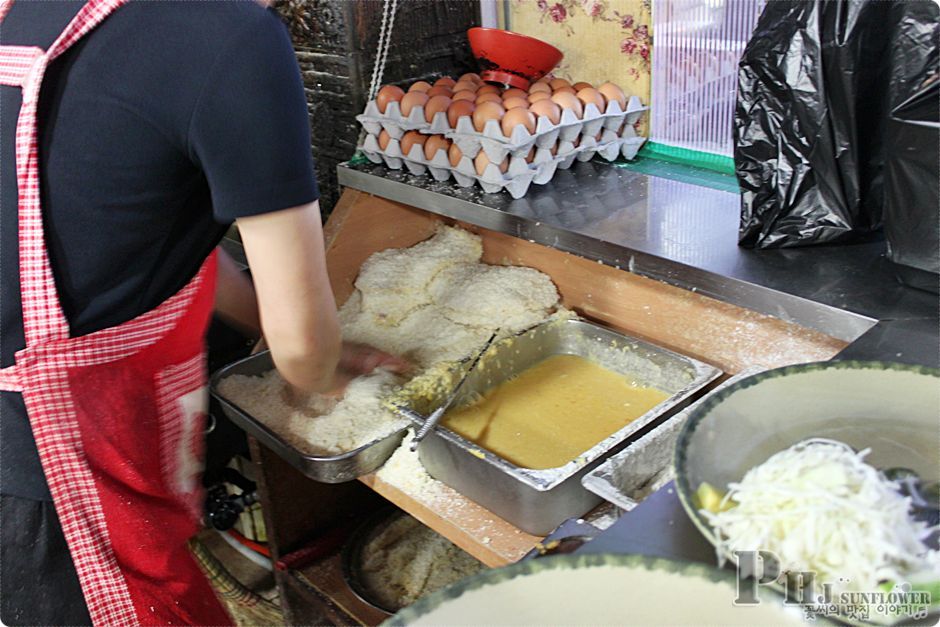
[325, 190, 846, 566]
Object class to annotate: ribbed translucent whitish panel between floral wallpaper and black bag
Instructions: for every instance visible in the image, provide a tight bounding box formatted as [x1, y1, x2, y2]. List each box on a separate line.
[650, 0, 765, 156]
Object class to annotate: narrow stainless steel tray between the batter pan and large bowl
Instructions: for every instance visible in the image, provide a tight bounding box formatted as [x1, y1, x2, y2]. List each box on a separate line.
[581, 368, 761, 511]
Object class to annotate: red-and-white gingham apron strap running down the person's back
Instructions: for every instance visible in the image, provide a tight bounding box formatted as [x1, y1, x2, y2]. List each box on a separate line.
[0, 0, 127, 348]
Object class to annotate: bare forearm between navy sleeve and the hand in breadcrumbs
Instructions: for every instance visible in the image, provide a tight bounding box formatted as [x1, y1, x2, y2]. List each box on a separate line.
[238, 202, 342, 392]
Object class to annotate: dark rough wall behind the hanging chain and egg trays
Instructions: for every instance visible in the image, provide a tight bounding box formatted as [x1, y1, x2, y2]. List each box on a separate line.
[275, 0, 480, 217]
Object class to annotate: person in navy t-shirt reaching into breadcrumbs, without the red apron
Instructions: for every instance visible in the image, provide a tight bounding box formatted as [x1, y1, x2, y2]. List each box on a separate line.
[0, 0, 405, 625]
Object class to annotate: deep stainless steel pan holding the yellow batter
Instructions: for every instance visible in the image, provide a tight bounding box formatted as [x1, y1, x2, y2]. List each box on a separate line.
[396, 320, 721, 535]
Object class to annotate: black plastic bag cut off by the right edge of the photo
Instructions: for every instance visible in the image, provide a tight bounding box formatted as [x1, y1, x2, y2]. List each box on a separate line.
[884, 2, 940, 292]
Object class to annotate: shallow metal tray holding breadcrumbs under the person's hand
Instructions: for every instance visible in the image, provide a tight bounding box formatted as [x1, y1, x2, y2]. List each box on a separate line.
[209, 351, 407, 483]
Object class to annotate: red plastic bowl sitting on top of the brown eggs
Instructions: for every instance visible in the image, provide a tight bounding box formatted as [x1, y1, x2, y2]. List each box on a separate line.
[467, 26, 565, 89]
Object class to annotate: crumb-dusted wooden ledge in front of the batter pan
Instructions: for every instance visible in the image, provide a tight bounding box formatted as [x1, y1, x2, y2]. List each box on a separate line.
[360, 473, 542, 567]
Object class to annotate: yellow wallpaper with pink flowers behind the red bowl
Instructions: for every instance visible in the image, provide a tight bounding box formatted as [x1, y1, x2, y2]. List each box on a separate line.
[504, 0, 653, 131]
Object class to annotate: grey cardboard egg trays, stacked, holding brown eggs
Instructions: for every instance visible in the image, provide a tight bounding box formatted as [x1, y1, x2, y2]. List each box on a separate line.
[356, 96, 648, 198]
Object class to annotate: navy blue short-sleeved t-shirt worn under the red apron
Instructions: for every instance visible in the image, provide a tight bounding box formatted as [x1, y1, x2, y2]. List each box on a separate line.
[0, 0, 317, 499]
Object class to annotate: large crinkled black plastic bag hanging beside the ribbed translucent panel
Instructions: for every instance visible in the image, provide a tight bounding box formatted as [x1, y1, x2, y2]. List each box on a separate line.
[734, 0, 895, 248]
